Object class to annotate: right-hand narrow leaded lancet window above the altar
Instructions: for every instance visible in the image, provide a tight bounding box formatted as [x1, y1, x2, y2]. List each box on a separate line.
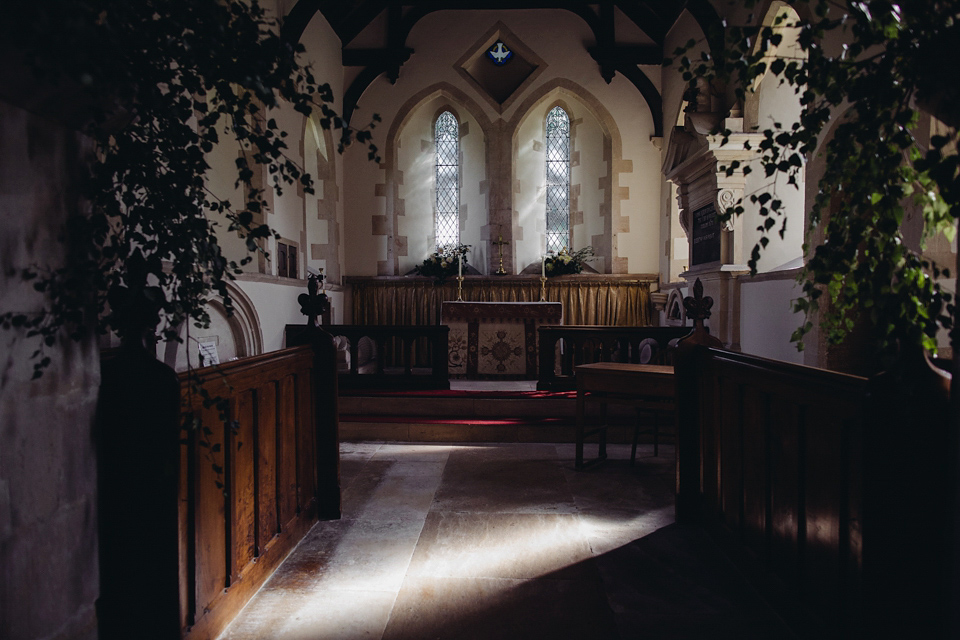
[547, 107, 570, 251]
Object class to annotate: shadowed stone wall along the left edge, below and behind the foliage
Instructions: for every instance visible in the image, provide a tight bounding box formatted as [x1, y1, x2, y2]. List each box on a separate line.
[0, 101, 100, 640]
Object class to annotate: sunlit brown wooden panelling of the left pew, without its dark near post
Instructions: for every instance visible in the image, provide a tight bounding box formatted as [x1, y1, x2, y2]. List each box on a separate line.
[180, 346, 339, 640]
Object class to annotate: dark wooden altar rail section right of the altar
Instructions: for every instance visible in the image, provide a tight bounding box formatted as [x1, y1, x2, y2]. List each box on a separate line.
[537, 326, 691, 391]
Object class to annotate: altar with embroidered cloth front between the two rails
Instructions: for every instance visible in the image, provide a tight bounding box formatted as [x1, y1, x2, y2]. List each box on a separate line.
[440, 302, 563, 380]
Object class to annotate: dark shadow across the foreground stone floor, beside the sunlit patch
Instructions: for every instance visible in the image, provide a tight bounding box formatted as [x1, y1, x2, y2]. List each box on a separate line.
[383, 524, 796, 640]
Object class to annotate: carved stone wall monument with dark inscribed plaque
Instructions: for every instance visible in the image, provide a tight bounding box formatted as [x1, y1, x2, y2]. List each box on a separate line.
[663, 113, 762, 351]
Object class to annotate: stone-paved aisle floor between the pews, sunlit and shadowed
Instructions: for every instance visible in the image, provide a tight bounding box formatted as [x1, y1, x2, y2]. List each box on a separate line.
[220, 443, 792, 640]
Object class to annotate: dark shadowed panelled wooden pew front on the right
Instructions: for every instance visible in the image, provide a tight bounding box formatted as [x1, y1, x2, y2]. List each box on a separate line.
[676, 347, 955, 638]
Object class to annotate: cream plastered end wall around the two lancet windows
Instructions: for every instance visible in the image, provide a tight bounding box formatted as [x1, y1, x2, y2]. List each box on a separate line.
[344, 10, 660, 275]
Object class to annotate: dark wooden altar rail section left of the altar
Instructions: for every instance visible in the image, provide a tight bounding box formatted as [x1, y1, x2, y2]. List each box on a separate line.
[286, 324, 450, 389]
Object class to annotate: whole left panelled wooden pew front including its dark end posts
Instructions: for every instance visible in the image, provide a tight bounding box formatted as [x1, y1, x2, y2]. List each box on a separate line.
[98, 336, 340, 640]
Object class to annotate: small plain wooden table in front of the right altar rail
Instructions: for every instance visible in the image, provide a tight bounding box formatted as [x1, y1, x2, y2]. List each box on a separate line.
[575, 362, 676, 469]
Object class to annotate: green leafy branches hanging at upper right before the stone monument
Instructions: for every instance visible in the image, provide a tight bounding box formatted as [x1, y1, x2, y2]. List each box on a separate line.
[664, 0, 960, 358]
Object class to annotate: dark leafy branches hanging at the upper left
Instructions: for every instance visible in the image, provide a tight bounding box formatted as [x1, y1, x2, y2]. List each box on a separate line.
[0, 0, 379, 377]
